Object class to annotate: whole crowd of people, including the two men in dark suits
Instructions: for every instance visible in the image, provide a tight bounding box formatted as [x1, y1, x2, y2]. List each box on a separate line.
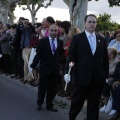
[0, 14, 120, 120]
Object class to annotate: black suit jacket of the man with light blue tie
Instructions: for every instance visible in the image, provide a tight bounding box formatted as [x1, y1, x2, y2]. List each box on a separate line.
[67, 32, 109, 85]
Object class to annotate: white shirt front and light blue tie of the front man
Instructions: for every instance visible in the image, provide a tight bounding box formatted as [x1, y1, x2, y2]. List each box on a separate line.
[85, 30, 96, 55]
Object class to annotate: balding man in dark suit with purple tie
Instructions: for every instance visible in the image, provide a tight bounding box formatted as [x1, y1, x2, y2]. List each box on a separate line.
[31, 24, 64, 112]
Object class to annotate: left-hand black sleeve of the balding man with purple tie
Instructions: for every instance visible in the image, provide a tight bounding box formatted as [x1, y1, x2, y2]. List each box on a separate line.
[30, 40, 42, 69]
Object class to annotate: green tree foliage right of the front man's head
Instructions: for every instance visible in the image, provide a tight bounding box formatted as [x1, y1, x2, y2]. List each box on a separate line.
[96, 13, 120, 31]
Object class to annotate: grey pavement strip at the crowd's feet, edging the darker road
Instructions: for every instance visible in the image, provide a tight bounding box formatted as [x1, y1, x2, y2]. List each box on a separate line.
[0, 74, 110, 120]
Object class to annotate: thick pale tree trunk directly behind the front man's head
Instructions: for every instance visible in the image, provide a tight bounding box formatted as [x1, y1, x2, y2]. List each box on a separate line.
[63, 0, 88, 31]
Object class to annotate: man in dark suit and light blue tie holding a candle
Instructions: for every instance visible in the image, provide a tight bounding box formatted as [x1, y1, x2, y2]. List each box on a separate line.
[65, 14, 109, 120]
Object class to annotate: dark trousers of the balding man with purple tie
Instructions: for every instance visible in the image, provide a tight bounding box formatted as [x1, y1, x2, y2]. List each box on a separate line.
[37, 74, 59, 108]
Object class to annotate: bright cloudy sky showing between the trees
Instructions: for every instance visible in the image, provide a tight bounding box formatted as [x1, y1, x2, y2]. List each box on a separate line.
[14, 0, 120, 24]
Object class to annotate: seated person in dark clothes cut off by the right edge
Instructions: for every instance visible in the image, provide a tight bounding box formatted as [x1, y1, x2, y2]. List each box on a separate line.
[108, 48, 120, 120]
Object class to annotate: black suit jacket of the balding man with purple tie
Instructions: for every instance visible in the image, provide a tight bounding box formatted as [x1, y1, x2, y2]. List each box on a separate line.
[31, 37, 64, 76]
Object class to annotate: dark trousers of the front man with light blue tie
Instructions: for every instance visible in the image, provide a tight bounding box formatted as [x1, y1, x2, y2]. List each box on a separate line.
[69, 83, 103, 120]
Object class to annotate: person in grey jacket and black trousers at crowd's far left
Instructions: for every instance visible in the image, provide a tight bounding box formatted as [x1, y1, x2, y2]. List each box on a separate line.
[0, 23, 12, 75]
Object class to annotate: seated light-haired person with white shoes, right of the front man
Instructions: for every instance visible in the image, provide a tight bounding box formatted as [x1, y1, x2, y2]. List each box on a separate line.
[100, 47, 120, 115]
